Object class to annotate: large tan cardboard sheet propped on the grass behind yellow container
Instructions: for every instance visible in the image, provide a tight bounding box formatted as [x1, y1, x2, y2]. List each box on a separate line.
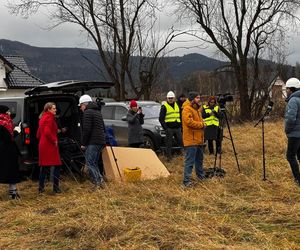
[102, 147, 170, 181]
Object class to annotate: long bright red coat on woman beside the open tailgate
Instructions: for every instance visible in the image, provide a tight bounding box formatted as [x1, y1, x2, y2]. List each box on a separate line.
[37, 112, 62, 166]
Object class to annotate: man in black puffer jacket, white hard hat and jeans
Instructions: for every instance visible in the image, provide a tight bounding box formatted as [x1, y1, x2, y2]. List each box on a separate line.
[79, 95, 106, 188]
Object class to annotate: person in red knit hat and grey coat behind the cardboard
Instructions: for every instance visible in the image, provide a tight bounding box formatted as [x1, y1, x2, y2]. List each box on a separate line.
[126, 100, 145, 148]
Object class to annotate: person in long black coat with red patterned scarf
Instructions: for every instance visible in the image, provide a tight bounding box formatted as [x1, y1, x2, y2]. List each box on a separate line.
[0, 105, 20, 199]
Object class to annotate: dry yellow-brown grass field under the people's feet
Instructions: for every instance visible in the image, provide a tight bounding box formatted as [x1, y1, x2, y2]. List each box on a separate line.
[0, 121, 300, 249]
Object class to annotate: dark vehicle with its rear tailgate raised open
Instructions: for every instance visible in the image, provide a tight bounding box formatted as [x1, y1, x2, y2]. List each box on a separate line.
[0, 81, 113, 171]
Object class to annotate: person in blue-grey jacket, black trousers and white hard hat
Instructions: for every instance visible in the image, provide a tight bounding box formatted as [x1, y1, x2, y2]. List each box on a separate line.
[285, 78, 300, 186]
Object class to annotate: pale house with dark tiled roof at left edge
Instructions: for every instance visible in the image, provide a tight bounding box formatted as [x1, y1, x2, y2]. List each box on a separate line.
[0, 54, 45, 97]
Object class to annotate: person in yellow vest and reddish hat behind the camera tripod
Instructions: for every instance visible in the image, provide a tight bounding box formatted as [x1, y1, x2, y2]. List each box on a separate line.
[202, 96, 221, 155]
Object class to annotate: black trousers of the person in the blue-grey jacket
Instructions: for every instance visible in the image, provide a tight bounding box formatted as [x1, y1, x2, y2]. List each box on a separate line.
[286, 137, 300, 183]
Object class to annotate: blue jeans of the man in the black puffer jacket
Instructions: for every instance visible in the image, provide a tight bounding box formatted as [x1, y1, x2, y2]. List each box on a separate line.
[85, 145, 104, 185]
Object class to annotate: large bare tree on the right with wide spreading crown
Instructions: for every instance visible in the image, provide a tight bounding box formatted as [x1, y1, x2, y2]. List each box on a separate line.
[176, 0, 300, 119]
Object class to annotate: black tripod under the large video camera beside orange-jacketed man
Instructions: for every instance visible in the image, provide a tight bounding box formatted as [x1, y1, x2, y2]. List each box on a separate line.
[214, 105, 241, 176]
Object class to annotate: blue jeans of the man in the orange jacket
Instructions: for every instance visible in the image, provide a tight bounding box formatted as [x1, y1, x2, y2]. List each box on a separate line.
[183, 145, 204, 184]
